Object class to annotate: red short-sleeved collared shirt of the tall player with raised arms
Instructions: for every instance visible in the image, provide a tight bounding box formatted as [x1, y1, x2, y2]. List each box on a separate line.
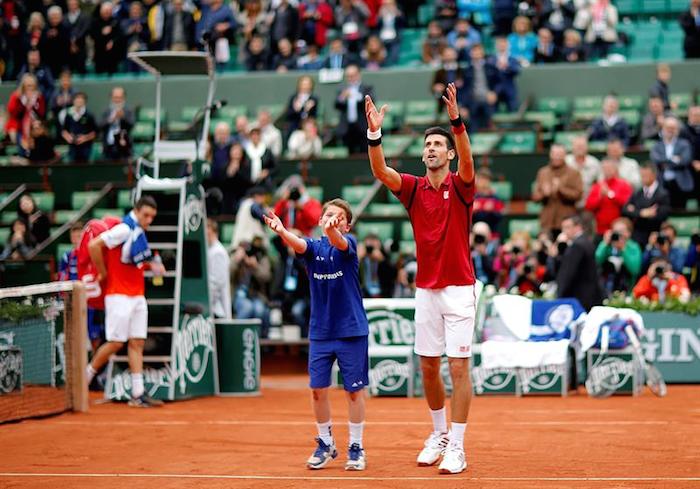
[395, 173, 475, 289]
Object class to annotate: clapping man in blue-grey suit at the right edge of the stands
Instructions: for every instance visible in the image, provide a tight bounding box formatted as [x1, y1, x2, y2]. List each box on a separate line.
[651, 117, 695, 209]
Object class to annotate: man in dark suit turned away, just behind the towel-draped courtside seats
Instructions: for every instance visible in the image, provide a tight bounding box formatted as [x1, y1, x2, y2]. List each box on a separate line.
[557, 215, 603, 311]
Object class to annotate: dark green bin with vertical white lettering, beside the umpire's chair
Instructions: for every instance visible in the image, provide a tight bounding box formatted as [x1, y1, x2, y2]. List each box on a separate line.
[216, 319, 261, 396]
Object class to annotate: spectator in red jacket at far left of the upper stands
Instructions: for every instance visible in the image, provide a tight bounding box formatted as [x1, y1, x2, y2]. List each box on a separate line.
[5, 73, 46, 155]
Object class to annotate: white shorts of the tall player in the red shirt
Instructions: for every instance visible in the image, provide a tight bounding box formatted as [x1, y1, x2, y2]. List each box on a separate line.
[413, 285, 476, 358]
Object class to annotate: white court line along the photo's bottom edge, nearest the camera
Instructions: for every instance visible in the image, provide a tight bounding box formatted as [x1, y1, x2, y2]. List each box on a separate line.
[0, 472, 700, 482]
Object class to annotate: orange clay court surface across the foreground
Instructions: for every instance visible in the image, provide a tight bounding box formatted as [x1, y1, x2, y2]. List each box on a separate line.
[0, 375, 700, 489]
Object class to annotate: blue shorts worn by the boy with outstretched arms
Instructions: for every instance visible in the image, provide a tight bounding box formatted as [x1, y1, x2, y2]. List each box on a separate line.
[309, 336, 369, 392]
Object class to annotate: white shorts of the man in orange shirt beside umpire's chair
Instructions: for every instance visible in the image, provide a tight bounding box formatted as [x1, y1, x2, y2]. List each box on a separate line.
[105, 294, 148, 342]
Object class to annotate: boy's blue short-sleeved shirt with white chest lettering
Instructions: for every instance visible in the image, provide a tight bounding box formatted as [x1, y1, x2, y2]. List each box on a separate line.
[302, 234, 369, 340]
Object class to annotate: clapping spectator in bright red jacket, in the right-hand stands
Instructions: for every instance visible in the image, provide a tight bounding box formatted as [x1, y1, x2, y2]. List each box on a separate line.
[586, 160, 632, 235]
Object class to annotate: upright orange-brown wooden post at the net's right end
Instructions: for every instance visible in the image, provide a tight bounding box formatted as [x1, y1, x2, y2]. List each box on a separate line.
[70, 281, 88, 413]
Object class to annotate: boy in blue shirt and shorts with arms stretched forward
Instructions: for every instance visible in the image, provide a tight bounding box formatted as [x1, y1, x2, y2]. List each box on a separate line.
[265, 199, 369, 470]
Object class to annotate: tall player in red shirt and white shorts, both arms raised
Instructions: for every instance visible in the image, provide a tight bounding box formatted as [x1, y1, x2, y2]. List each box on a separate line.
[365, 83, 476, 474]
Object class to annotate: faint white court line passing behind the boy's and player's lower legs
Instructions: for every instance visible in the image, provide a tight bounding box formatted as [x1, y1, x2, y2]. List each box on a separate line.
[50, 419, 680, 426]
